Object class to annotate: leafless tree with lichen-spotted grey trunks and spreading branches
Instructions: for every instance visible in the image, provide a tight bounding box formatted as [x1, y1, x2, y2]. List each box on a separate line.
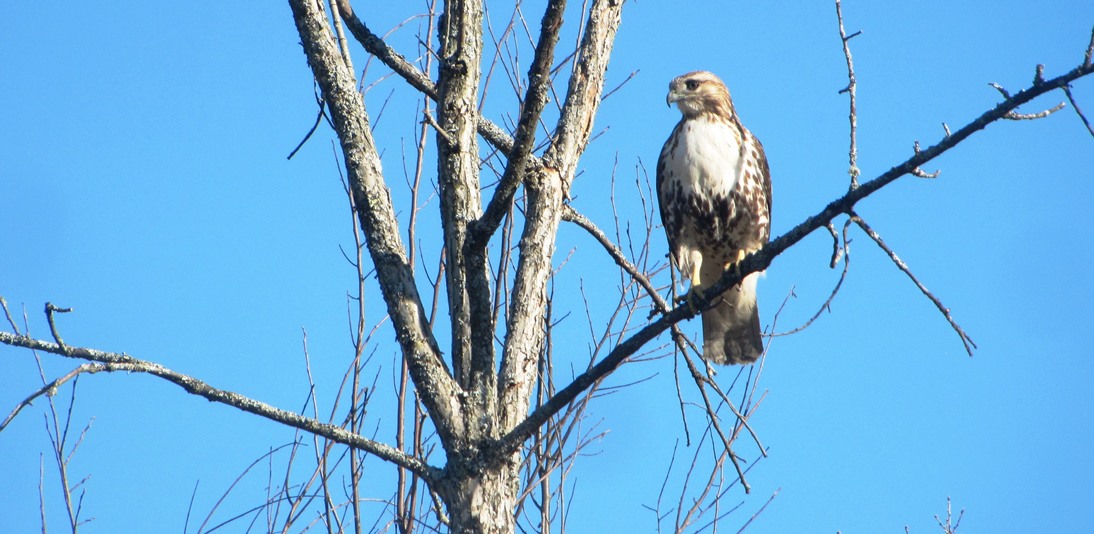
[0, 0, 1094, 533]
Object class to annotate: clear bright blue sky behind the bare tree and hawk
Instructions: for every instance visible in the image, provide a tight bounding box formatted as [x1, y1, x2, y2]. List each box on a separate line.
[0, 0, 1094, 534]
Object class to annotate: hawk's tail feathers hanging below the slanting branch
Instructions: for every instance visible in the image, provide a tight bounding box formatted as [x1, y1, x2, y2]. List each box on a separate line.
[702, 274, 764, 365]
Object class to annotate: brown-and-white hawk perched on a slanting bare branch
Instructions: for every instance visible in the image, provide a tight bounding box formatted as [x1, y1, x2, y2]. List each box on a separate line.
[657, 71, 771, 364]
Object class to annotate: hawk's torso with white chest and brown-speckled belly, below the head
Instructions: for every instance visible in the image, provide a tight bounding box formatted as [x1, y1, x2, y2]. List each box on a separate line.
[657, 116, 771, 267]
